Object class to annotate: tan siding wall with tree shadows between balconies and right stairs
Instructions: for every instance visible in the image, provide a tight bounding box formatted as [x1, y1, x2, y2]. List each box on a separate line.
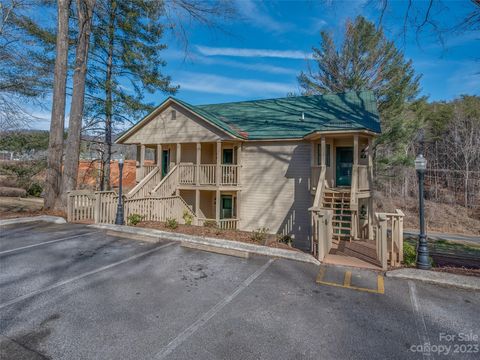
[240, 141, 312, 249]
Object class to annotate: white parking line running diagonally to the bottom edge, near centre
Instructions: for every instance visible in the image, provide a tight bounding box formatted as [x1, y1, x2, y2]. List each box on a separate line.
[155, 259, 275, 360]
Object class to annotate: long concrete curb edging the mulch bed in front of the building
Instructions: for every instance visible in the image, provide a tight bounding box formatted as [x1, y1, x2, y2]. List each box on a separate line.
[88, 224, 320, 265]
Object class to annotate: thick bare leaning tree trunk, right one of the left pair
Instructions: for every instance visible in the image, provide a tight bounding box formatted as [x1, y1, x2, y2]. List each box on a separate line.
[62, 0, 95, 207]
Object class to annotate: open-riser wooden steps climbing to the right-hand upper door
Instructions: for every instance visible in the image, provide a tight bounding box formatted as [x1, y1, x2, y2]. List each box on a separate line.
[322, 189, 352, 241]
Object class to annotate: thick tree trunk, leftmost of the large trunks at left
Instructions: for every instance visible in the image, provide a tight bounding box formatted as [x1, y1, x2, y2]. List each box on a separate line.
[45, 0, 70, 209]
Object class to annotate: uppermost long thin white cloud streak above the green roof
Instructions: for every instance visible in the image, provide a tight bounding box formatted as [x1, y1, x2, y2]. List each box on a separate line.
[196, 45, 312, 60]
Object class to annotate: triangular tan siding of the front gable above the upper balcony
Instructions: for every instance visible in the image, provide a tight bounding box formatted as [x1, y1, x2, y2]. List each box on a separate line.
[125, 105, 230, 144]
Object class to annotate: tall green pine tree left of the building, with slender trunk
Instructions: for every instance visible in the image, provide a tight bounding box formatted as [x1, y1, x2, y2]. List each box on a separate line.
[87, 0, 177, 190]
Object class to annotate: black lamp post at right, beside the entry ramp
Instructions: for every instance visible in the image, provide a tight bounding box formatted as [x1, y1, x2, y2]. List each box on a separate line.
[415, 154, 430, 270]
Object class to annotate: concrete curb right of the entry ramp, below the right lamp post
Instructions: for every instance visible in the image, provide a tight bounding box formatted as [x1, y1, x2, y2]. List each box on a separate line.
[385, 268, 480, 290]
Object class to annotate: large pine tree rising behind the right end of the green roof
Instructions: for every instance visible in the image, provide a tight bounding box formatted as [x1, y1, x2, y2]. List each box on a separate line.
[298, 16, 420, 161]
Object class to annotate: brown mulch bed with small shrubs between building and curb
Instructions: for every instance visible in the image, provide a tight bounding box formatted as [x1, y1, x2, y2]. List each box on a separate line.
[136, 221, 300, 251]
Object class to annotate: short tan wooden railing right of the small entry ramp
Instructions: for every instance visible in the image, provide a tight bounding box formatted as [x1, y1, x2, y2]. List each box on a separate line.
[374, 209, 405, 269]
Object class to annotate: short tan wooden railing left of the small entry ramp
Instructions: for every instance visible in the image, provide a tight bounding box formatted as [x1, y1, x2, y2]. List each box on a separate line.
[310, 208, 333, 261]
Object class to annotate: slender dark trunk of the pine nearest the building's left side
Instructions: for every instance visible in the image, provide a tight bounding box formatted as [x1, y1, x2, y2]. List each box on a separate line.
[103, 0, 117, 190]
